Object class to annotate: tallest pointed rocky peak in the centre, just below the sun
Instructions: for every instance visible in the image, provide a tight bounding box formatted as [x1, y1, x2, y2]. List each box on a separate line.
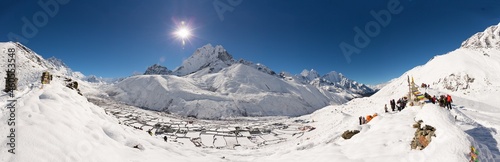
[173, 44, 234, 76]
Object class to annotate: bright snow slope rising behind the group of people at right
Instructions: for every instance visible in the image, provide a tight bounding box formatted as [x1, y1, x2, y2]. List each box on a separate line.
[370, 22, 500, 161]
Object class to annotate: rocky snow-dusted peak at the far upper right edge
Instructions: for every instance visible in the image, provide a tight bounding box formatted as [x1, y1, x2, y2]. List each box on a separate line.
[461, 24, 500, 49]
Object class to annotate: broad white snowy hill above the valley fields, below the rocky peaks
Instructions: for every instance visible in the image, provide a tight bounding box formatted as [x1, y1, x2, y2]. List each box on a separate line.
[108, 64, 348, 118]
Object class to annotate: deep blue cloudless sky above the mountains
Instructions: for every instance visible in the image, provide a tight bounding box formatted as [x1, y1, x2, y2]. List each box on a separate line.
[0, 0, 500, 84]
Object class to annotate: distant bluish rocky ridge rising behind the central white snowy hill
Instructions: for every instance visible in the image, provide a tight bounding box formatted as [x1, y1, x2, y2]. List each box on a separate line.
[144, 44, 375, 96]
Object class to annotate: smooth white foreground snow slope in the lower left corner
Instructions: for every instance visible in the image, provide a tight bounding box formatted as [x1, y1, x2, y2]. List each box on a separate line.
[0, 79, 223, 162]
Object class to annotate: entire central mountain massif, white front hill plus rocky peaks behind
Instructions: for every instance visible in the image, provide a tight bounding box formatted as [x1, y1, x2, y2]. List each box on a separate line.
[109, 44, 372, 118]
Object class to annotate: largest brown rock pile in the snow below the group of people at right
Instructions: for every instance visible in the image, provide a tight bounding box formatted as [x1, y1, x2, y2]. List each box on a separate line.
[410, 120, 436, 150]
